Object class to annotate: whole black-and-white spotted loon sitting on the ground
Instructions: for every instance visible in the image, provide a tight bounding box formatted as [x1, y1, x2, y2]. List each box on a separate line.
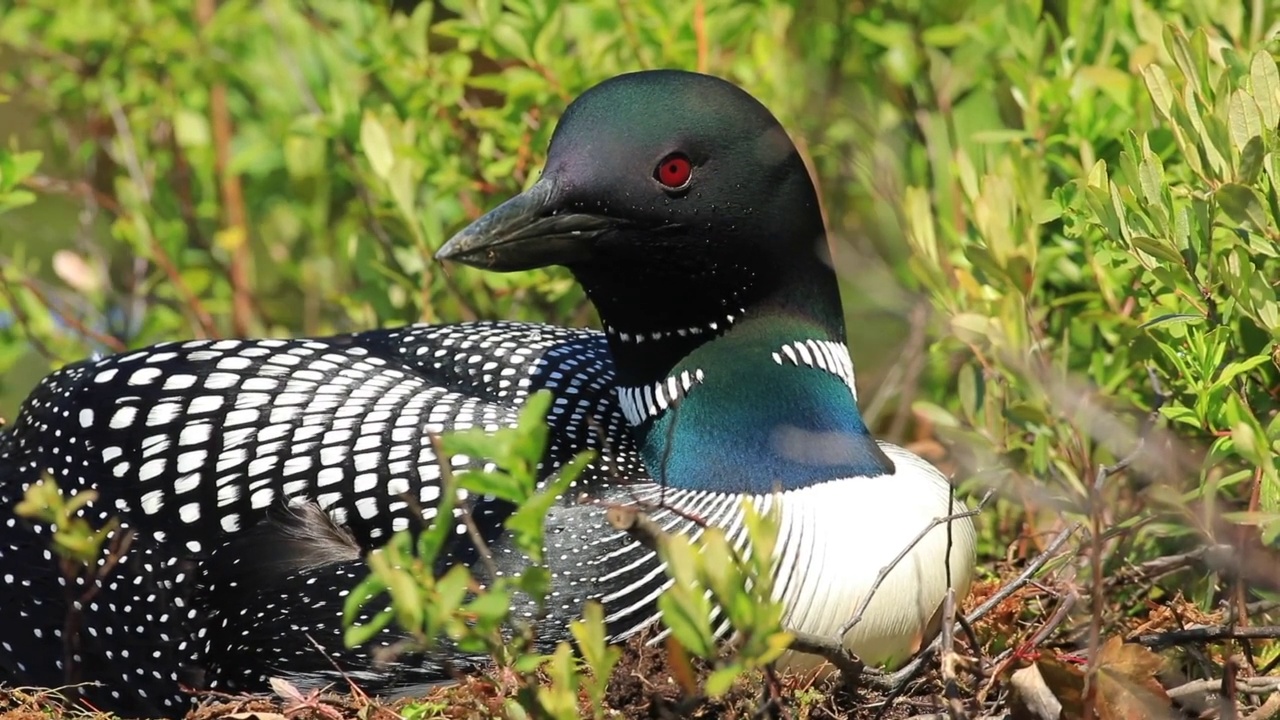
[0, 69, 977, 716]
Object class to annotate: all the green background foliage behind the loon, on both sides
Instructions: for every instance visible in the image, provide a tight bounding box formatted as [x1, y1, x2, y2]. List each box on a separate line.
[0, 0, 1280, 671]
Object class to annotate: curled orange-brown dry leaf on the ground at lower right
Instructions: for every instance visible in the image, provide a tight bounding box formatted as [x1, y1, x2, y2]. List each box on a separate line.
[1093, 635, 1172, 720]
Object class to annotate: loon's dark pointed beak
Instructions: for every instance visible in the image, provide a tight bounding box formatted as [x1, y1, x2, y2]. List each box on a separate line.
[435, 178, 618, 272]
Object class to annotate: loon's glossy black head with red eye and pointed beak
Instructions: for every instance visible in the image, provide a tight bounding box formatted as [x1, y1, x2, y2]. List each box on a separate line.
[436, 70, 844, 380]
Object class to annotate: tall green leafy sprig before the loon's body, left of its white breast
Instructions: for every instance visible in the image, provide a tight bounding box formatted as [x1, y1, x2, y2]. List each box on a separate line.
[344, 391, 609, 719]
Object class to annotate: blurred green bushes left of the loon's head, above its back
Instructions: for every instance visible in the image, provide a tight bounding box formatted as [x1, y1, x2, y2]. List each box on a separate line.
[0, 0, 787, 373]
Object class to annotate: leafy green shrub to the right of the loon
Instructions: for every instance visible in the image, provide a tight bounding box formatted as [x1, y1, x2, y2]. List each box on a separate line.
[860, 3, 1280, 589]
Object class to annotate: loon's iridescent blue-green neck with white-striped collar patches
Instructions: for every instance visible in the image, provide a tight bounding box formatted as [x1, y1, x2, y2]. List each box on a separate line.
[617, 318, 893, 493]
